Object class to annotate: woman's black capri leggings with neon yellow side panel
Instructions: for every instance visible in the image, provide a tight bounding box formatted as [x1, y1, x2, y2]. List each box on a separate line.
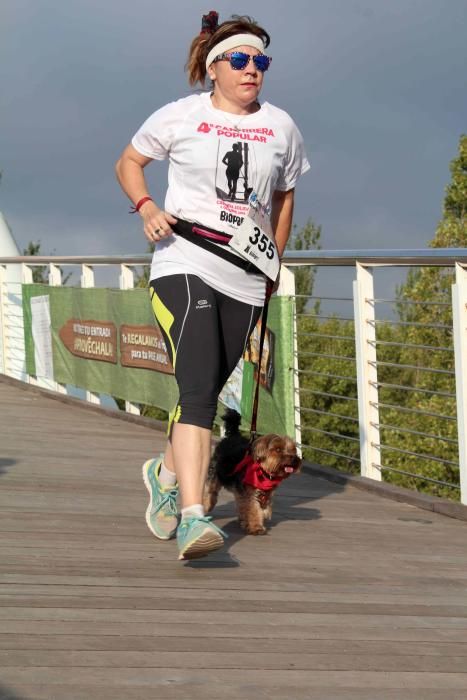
[150, 274, 261, 434]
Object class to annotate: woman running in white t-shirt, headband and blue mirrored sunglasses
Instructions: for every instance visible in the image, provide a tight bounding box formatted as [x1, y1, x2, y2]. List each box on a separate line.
[116, 12, 310, 559]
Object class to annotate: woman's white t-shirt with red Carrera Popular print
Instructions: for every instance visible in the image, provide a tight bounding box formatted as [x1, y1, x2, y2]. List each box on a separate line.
[132, 92, 310, 306]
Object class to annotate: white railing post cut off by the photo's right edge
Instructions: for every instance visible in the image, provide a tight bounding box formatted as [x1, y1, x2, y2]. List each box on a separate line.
[452, 263, 467, 505]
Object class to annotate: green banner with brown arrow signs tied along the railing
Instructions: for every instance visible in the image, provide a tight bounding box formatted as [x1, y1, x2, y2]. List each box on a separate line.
[23, 284, 294, 436]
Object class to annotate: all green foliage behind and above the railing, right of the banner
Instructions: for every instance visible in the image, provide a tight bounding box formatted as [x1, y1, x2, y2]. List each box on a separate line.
[298, 136, 467, 499]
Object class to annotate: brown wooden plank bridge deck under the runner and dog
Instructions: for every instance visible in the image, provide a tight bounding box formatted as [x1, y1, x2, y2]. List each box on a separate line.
[0, 380, 467, 700]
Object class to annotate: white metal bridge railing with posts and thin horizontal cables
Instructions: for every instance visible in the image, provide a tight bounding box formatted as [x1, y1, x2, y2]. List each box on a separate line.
[0, 249, 467, 504]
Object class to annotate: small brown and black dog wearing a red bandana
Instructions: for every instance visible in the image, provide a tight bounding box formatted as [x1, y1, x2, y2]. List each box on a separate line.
[204, 409, 302, 535]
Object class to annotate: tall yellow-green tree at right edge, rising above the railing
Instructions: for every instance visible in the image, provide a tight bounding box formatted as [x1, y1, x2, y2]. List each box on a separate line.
[372, 135, 467, 497]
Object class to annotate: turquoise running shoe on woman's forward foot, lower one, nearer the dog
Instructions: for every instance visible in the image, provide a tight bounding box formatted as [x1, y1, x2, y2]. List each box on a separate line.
[177, 515, 228, 559]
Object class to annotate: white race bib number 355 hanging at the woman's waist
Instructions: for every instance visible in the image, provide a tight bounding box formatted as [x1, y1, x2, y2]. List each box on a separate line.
[229, 197, 280, 282]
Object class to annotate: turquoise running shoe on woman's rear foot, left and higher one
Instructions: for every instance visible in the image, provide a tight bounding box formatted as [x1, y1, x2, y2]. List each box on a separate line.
[143, 458, 178, 540]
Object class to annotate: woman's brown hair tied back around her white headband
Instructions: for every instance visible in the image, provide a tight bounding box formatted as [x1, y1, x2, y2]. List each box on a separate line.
[185, 11, 271, 85]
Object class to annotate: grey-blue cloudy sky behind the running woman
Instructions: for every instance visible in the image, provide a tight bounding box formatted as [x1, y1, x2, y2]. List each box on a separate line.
[0, 0, 467, 278]
